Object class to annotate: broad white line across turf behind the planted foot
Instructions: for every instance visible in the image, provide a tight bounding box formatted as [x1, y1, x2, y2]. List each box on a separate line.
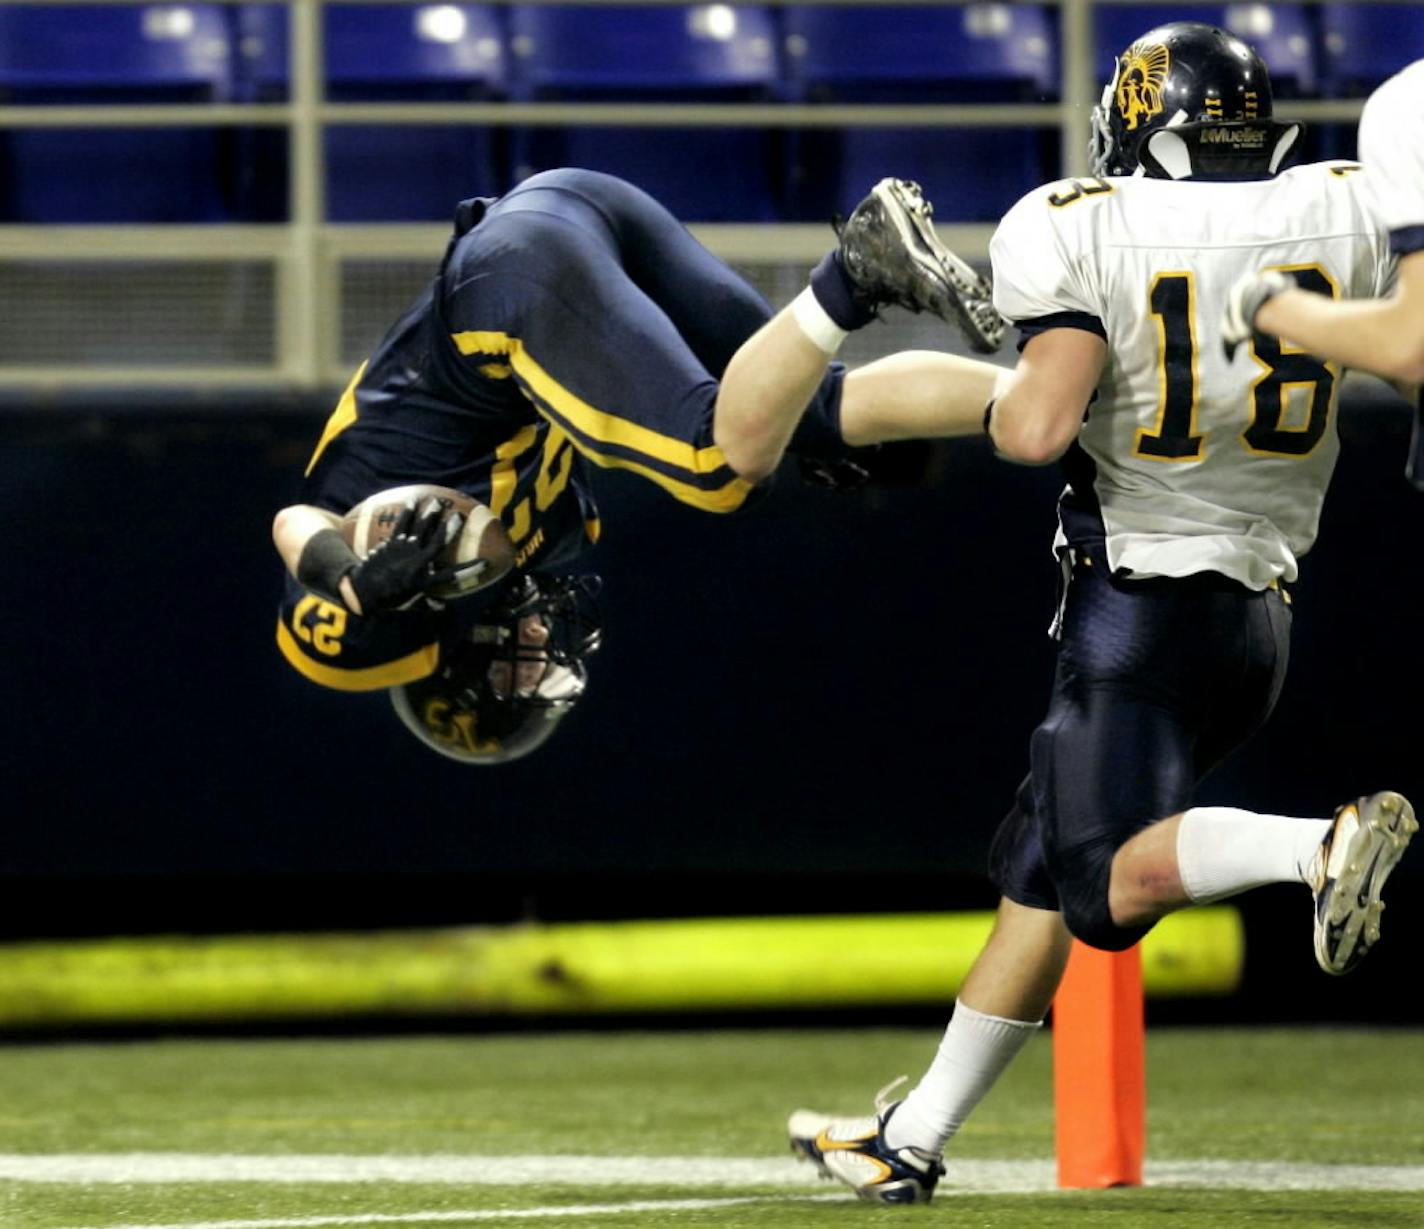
[0, 1152, 1424, 1190]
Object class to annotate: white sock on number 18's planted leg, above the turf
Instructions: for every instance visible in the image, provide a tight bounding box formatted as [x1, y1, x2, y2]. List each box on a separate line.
[886, 1003, 1044, 1154]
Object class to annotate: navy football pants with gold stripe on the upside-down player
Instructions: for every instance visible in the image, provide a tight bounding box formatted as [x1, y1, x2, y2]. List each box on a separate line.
[443, 168, 846, 478]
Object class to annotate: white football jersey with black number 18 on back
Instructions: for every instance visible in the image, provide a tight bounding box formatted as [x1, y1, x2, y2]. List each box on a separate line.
[990, 162, 1393, 588]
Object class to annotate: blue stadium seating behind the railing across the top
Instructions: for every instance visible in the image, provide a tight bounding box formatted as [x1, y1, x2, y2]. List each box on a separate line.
[0, 0, 1424, 222]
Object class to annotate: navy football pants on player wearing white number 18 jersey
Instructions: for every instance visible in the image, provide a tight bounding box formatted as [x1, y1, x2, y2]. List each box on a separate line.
[990, 551, 1290, 950]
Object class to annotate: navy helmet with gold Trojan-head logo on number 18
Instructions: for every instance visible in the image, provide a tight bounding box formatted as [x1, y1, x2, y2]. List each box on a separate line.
[1091, 21, 1302, 179]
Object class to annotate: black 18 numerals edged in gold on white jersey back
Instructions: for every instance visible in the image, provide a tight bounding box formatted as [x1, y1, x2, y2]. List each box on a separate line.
[1134, 265, 1337, 461]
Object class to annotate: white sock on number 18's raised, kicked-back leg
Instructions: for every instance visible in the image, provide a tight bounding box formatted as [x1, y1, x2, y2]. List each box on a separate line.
[1176, 806, 1330, 904]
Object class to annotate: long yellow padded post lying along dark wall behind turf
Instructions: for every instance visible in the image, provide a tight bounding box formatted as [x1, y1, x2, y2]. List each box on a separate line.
[0, 906, 1245, 1028]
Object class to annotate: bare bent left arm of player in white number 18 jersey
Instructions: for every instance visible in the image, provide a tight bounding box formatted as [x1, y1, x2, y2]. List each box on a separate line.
[988, 328, 1108, 466]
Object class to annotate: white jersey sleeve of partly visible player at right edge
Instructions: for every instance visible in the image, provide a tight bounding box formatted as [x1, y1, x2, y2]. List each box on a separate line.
[1360, 60, 1424, 253]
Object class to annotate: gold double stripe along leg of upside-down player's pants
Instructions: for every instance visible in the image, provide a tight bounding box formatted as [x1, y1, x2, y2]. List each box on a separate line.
[451, 332, 752, 511]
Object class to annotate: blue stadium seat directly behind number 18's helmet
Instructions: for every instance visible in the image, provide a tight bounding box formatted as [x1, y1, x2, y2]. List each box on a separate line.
[1094, 4, 1320, 98]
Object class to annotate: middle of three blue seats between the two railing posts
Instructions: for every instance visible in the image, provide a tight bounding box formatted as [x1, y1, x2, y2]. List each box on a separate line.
[510, 4, 785, 222]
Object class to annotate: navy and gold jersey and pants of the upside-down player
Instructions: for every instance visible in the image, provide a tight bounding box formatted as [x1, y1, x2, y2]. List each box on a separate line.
[278, 169, 844, 689]
